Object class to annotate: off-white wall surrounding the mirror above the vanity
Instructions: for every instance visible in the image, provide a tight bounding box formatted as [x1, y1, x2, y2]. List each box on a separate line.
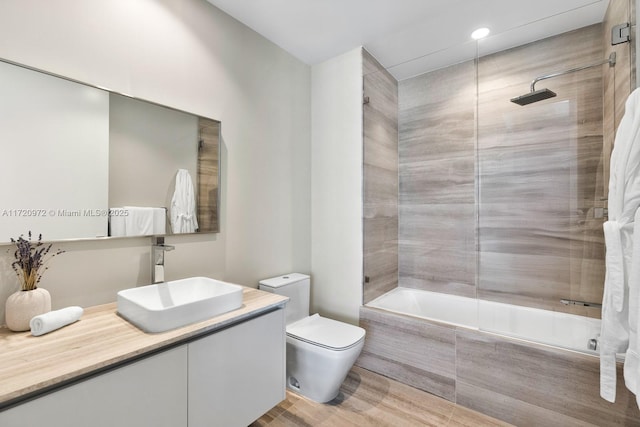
[0, 0, 311, 320]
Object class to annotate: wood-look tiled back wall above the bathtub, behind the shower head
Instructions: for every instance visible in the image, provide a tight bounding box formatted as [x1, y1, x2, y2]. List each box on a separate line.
[398, 24, 625, 317]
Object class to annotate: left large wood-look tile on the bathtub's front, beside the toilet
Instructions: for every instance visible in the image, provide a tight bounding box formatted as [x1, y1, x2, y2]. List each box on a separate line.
[356, 307, 456, 401]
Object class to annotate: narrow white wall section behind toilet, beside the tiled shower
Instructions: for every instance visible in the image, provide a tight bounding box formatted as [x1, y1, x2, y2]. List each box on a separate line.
[311, 48, 363, 324]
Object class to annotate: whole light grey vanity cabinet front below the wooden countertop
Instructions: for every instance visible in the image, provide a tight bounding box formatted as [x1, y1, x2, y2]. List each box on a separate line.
[0, 308, 286, 427]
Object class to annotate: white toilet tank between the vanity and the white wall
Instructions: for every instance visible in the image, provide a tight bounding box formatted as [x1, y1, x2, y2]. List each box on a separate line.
[259, 273, 311, 325]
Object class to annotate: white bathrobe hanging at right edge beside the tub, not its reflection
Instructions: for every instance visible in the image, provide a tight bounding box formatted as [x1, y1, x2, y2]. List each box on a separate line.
[600, 89, 640, 406]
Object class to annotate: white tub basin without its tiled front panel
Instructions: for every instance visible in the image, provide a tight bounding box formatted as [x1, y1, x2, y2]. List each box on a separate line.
[367, 287, 600, 355]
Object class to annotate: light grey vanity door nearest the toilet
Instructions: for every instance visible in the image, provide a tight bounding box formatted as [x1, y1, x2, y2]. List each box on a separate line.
[189, 309, 285, 427]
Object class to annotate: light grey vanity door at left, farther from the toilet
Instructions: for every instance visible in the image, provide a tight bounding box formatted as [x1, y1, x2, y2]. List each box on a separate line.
[0, 345, 187, 427]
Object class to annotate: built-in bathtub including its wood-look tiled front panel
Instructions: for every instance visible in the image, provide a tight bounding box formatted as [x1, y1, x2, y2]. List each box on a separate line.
[356, 287, 640, 426]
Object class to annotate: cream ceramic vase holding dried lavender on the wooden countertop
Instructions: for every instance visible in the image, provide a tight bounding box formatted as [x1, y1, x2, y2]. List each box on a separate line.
[4, 288, 51, 332]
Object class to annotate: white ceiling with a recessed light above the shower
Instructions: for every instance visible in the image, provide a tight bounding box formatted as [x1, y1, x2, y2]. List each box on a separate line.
[207, 0, 609, 80]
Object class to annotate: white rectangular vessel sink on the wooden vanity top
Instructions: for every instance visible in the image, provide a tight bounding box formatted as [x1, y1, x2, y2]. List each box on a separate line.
[118, 277, 242, 332]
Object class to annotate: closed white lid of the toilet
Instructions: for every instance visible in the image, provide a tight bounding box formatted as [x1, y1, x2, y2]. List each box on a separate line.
[287, 314, 365, 350]
